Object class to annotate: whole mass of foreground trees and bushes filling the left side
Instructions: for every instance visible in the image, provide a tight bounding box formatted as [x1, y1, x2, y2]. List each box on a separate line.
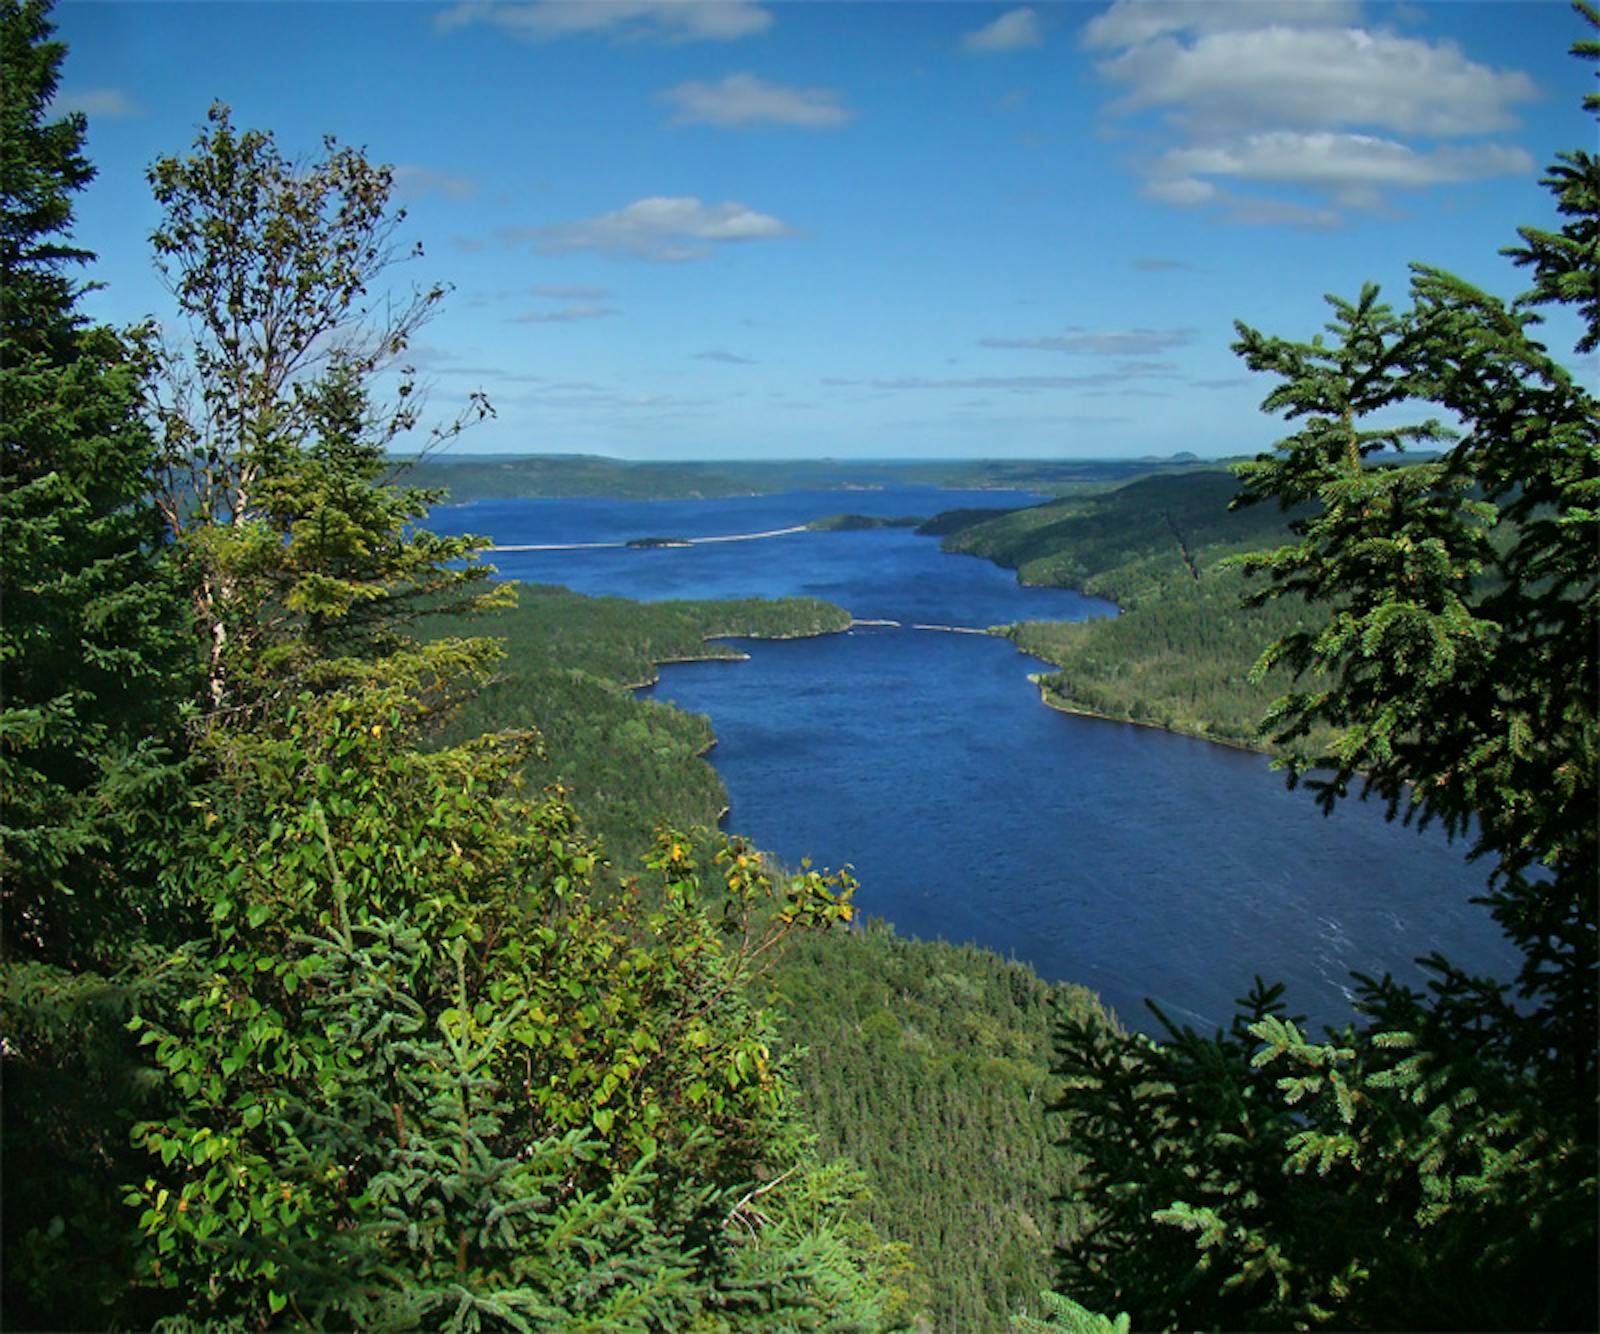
[0, 59, 902, 1331]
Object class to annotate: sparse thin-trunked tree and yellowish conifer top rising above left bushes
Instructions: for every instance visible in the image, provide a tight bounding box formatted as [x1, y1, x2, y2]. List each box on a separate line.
[142, 104, 490, 709]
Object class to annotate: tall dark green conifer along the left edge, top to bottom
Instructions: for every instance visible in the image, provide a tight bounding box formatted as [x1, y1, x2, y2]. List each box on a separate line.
[0, 0, 192, 1328]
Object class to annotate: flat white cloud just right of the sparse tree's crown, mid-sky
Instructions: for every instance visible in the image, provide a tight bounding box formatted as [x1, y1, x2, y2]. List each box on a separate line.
[518, 195, 792, 262]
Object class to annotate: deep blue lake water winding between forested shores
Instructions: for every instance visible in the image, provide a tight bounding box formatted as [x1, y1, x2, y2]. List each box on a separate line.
[434, 488, 1514, 1028]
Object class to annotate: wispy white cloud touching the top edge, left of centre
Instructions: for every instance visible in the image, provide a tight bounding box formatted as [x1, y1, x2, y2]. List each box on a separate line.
[437, 0, 773, 43]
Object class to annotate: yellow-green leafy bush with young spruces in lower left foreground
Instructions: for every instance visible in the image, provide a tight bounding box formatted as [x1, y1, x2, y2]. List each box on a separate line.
[128, 671, 880, 1329]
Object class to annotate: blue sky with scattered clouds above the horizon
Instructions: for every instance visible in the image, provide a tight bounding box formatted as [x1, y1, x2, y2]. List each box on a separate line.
[56, 0, 1595, 459]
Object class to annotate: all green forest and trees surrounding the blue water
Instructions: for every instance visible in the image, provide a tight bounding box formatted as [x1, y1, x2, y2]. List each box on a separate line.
[0, 0, 1600, 1334]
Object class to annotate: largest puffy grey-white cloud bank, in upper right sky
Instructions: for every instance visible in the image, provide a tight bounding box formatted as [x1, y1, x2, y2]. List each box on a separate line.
[1083, 0, 1538, 227]
